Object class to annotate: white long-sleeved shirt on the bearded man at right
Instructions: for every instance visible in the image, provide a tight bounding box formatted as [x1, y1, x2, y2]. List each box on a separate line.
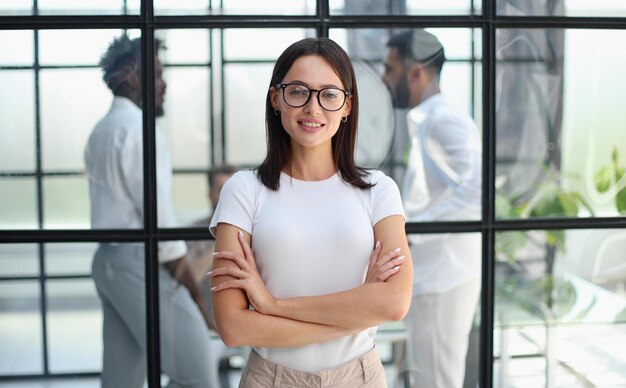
[402, 94, 482, 295]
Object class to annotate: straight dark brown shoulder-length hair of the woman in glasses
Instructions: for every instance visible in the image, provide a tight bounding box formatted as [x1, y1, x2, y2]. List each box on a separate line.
[258, 38, 372, 190]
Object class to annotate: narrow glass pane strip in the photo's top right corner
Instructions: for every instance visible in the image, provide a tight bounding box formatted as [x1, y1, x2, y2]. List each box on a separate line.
[497, 0, 626, 17]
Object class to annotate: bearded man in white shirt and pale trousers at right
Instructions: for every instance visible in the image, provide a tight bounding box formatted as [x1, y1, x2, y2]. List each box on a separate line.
[383, 29, 482, 388]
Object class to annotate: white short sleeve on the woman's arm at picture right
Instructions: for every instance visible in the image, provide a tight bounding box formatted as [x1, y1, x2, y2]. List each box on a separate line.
[371, 171, 406, 225]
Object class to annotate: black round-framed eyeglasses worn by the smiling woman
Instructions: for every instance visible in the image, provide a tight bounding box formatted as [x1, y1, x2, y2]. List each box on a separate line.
[276, 84, 350, 112]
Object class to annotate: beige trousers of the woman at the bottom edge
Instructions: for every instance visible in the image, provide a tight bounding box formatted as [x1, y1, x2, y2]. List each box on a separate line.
[239, 348, 387, 388]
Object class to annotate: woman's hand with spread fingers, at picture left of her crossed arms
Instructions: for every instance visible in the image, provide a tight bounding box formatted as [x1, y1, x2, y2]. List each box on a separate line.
[208, 232, 276, 314]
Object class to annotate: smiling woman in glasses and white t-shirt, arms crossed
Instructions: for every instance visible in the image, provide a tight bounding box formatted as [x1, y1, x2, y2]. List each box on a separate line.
[210, 39, 412, 388]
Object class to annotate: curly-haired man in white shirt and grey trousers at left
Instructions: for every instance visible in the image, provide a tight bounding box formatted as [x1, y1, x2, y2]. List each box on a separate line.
[85, 34, 210, 388]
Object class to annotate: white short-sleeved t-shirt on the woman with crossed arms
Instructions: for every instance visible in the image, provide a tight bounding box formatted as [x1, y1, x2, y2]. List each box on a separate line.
[210, 171, 404, 372]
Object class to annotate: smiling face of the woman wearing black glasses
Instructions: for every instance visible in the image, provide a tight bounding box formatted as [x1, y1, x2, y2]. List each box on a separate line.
[270, 55, 352, 150]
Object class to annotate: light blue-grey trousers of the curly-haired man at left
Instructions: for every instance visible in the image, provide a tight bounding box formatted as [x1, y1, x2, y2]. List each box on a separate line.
[92, 244, 210, 388]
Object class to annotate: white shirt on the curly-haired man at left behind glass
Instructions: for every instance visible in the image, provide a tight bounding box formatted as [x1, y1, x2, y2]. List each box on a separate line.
[85, 97, 187, 262]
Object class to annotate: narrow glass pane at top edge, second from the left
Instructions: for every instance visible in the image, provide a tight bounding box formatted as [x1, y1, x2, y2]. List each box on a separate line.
[154, 0, 315, 15]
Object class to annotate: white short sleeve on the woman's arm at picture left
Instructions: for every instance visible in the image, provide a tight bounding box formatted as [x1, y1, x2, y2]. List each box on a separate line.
[209, 171, 260, 237]
